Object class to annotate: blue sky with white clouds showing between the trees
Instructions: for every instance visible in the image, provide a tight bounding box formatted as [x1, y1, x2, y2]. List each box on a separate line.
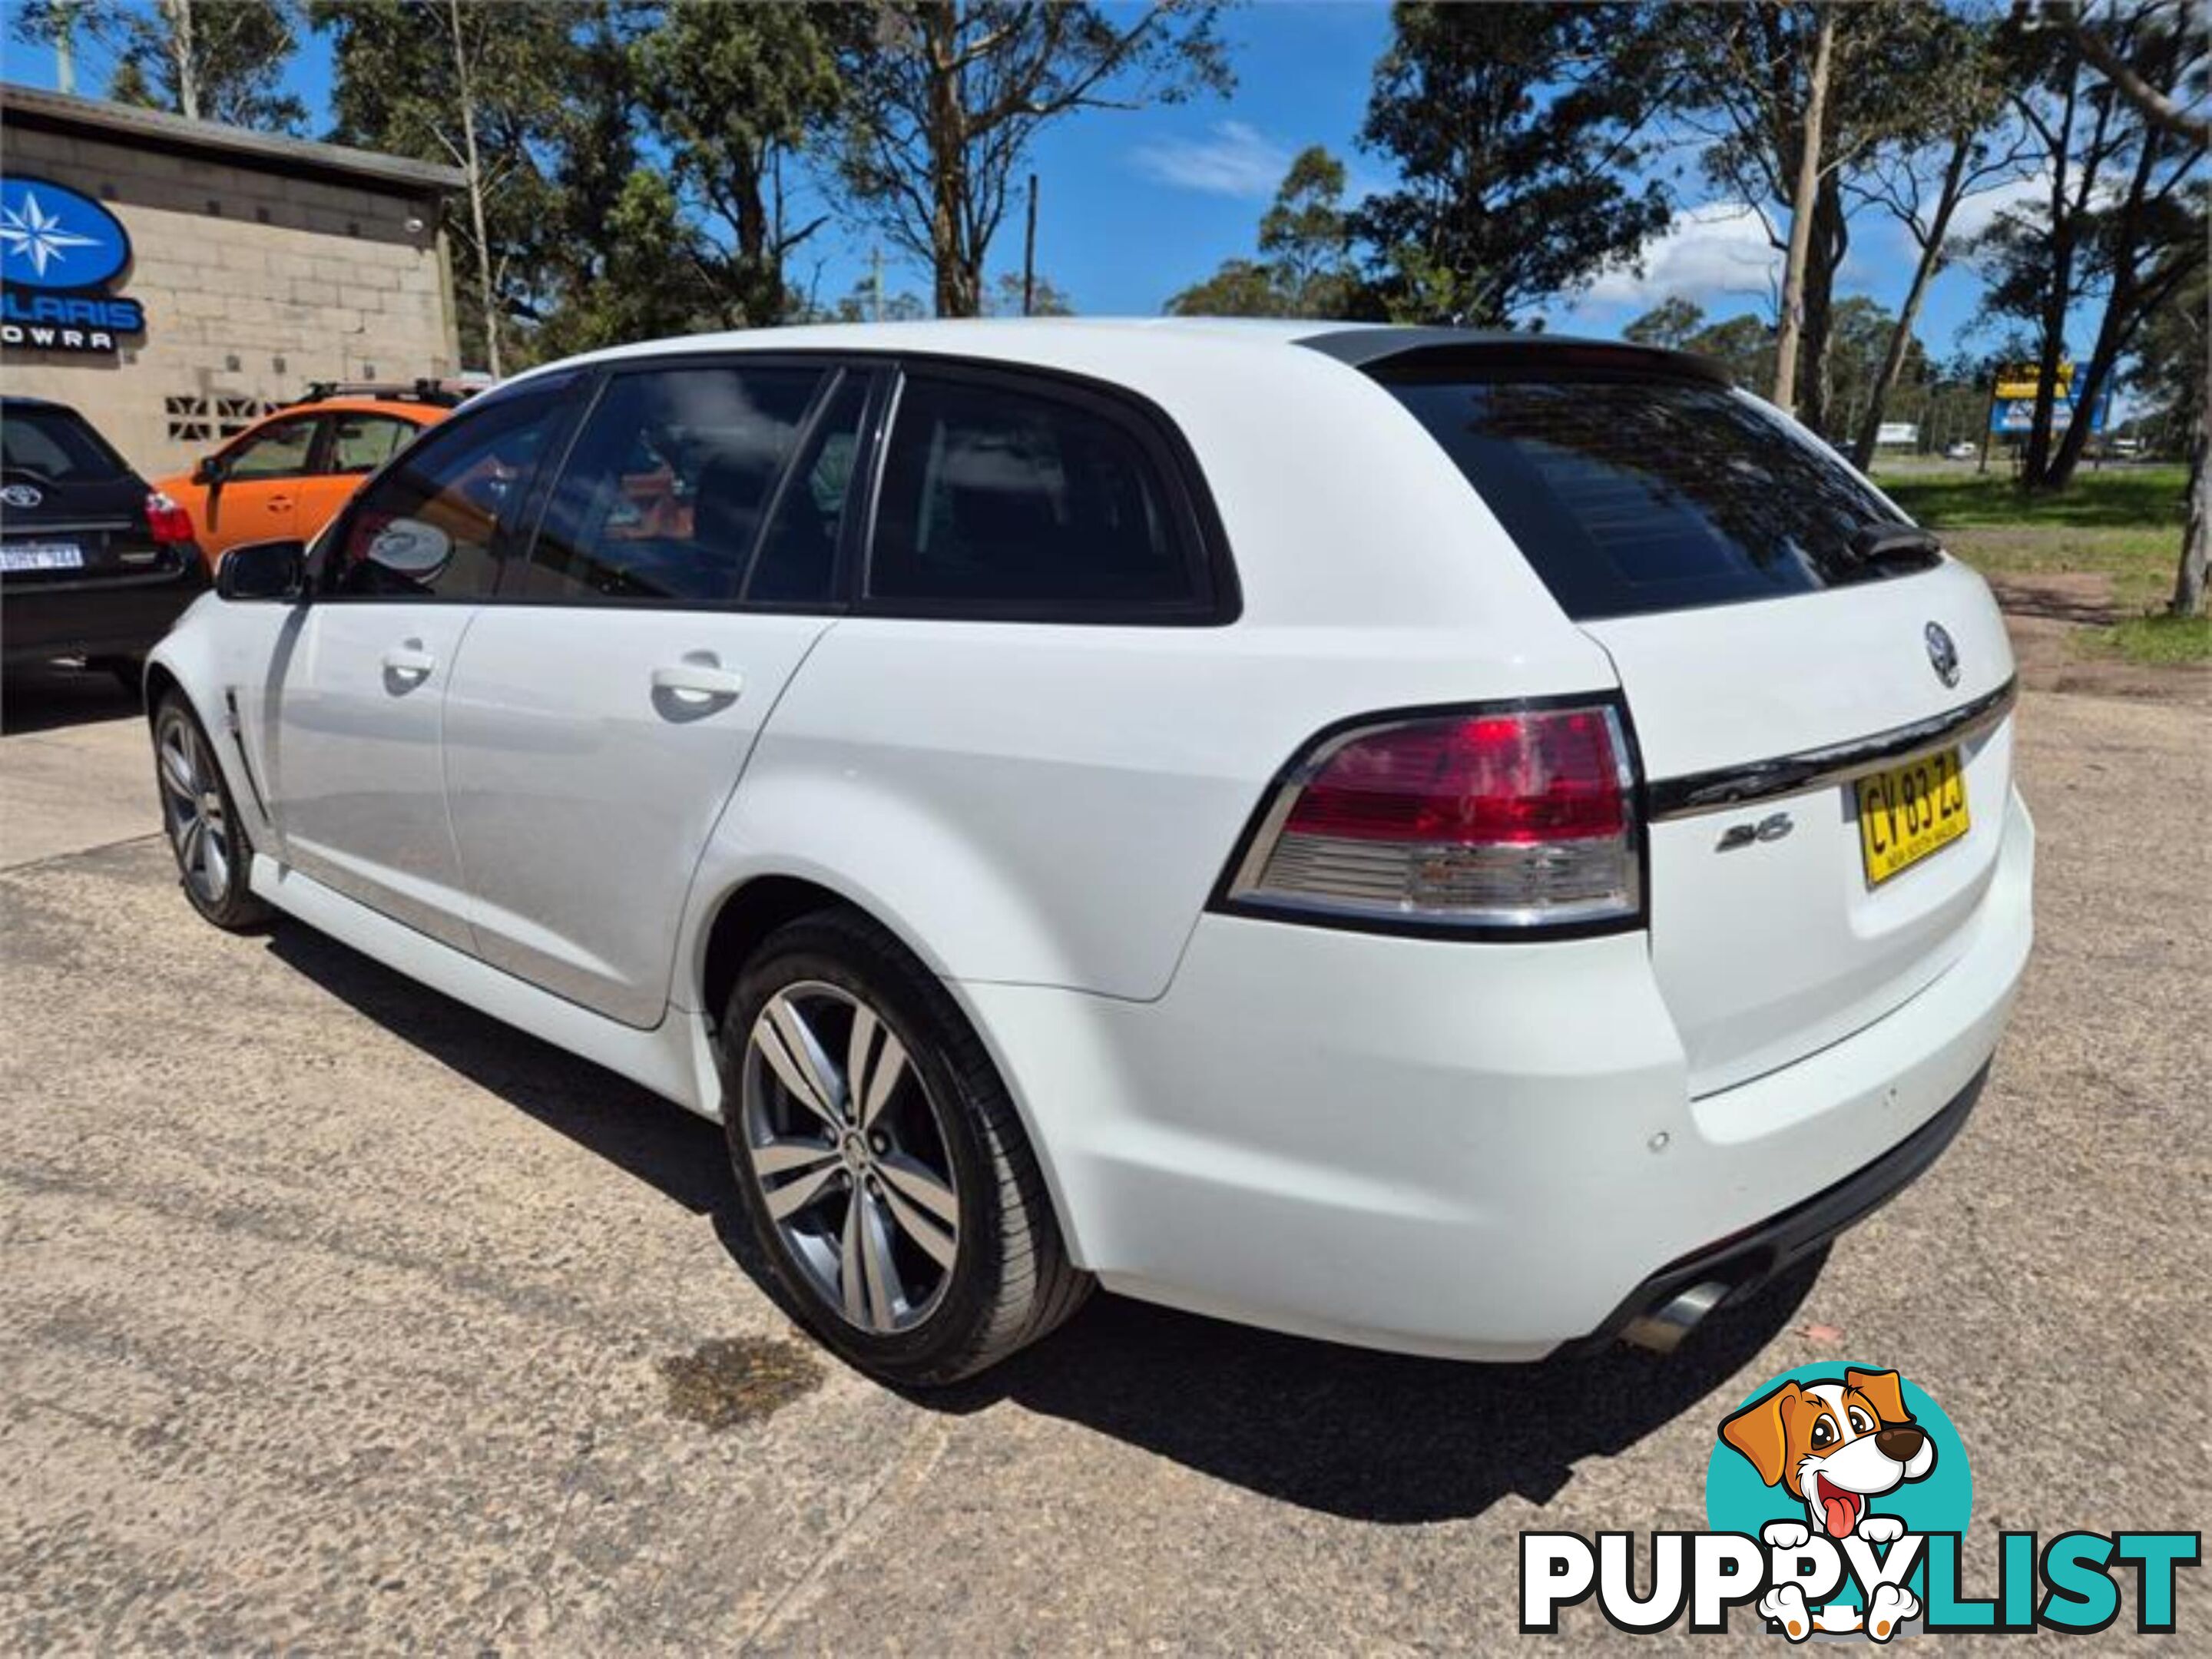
[7, 0, 2026, 356]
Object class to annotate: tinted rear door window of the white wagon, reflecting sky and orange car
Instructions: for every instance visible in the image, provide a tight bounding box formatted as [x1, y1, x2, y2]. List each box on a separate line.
[525, 367, 823, 599]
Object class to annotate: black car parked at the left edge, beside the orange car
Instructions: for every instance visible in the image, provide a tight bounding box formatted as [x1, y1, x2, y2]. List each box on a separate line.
[0, 398, 208, 690]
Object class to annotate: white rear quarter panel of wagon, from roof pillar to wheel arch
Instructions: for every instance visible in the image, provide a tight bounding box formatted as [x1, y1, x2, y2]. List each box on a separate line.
[677, 349, 1614, 1002]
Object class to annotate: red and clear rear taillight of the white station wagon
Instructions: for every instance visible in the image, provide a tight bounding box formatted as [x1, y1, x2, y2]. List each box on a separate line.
[1224, 704, 1644, 931]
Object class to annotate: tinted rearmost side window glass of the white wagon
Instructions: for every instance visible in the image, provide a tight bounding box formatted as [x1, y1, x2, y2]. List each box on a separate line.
[867, 374, 1204, 615]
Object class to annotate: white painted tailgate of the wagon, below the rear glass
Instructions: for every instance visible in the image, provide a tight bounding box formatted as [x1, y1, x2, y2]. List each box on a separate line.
[1581, 564, 2013, 1095]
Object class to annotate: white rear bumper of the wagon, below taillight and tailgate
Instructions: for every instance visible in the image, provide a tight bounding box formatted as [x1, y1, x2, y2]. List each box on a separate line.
[955, 796, 2033, 1360]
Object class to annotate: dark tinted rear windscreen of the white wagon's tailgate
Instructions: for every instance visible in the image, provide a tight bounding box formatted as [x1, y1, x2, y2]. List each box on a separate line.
[1385, 372, 1936, 621]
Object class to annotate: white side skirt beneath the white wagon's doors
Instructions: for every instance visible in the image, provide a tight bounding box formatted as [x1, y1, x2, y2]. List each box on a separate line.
[252, 852, 721, 1121]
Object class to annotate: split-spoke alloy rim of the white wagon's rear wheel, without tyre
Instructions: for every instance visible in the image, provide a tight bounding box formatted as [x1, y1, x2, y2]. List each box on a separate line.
[741, 980, 960, 1336]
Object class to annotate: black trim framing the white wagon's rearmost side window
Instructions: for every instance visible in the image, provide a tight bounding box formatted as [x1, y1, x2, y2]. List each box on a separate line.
[852, 352, 1243, 628]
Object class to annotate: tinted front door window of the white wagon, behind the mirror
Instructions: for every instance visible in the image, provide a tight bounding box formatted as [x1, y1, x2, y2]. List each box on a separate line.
[323, 380, 575, 599]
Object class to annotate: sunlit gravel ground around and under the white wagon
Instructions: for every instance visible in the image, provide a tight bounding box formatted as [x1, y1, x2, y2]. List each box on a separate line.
[0, 667, 2212, 1652]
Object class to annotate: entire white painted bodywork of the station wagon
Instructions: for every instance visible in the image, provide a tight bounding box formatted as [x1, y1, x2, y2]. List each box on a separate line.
[153, 323, 2033, 1358]
